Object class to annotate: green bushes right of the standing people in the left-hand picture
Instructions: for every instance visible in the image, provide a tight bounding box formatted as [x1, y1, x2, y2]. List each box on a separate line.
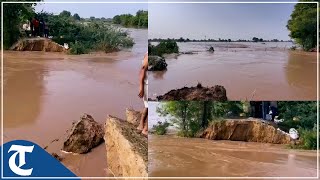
[38, 10, 134, 54]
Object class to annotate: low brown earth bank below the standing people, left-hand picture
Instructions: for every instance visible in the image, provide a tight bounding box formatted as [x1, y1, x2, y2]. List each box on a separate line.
[10, 38, 66, 52]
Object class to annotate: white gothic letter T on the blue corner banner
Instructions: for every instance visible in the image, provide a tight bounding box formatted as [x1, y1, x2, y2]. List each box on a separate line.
[8, 145, 34, 176]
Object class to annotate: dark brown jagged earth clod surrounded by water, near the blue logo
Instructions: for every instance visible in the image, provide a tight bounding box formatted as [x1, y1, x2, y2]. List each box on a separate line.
[63, 114, 104, 154]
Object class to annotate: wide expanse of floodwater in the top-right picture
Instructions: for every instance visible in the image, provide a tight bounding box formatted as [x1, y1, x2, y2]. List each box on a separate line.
[149, 42, 317, 100]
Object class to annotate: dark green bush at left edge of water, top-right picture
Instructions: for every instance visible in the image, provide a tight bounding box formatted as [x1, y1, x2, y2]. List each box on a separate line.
[148, 39, 179, 56]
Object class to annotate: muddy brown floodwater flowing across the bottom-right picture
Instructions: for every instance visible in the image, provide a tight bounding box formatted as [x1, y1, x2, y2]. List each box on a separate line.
[148, 135, 317, 177]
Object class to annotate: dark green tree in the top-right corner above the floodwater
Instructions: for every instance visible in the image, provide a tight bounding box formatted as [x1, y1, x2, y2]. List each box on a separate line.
[287, 0, 318, 50]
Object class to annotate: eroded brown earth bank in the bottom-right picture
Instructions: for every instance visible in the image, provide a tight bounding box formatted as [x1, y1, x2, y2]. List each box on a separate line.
[199, 119, 290, 144]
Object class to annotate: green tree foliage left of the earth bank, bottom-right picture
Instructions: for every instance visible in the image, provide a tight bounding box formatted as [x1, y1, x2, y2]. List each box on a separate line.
[157, 101, 243, 137]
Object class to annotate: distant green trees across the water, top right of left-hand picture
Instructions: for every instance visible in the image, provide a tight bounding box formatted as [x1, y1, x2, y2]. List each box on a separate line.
[112, 10, 148, 28]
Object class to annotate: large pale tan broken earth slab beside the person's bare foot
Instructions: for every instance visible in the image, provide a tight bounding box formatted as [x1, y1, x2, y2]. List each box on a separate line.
[104, 116, 148, 177]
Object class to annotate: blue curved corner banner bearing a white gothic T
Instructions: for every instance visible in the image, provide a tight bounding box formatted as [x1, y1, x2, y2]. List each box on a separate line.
[0, 140, 80, 179]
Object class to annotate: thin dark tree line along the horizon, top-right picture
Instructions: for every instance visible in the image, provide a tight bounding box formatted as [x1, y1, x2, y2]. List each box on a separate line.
[149, 37, 292, 42]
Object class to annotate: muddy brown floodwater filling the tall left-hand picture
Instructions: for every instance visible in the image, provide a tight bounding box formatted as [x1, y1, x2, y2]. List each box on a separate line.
[4, 29, 147, 177]
